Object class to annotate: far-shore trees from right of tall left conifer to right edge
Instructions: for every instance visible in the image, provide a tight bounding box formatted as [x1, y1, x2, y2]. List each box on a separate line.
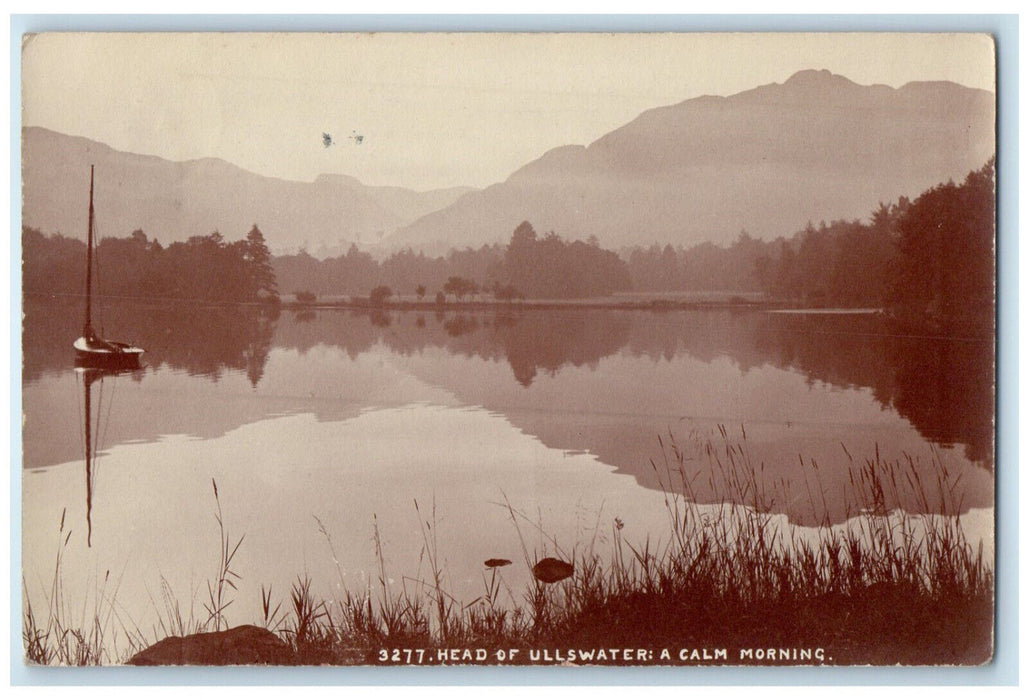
[275, 160, 994, 326]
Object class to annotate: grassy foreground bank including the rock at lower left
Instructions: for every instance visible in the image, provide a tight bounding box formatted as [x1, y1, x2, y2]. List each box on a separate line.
[23, 442, 994, 665]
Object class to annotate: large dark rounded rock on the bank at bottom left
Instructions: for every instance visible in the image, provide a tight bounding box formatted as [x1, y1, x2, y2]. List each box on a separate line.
[129, 625, 293, 666]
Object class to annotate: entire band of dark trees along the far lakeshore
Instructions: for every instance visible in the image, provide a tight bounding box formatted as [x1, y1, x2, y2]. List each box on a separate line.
[23, 159, 995, 331]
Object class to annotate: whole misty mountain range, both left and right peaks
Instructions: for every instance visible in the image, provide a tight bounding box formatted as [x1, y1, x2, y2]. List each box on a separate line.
[23, 69, 995, 257]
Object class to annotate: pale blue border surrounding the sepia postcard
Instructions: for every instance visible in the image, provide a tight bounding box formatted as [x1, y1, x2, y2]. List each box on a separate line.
[10, 14, 1019, 686]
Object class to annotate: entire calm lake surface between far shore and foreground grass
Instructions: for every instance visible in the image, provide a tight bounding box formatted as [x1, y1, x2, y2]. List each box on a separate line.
[23, 300, 993, 632]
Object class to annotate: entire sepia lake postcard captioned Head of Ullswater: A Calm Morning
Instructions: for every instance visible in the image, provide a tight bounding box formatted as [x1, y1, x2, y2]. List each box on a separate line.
[18, 32, 996, 673]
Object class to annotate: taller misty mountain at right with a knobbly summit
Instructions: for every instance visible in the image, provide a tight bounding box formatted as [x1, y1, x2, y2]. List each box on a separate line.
[383, 70, 995, 252]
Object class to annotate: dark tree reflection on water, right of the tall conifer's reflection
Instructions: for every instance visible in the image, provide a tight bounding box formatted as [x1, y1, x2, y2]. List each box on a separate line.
[276, 311, 994, 468]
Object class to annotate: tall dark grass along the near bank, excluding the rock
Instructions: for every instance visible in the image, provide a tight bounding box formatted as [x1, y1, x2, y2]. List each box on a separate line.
[25, 427, 994, 664]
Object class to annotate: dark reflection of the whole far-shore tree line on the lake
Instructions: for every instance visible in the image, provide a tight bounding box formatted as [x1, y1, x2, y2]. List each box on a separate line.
[23, 298, 994, 469]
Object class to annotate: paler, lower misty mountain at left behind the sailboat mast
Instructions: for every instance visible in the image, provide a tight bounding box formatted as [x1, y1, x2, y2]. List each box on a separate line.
[22, 127, 470, 254]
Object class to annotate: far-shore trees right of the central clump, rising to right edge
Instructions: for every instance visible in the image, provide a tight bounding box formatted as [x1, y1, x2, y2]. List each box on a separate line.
[624, 159, 995, 329]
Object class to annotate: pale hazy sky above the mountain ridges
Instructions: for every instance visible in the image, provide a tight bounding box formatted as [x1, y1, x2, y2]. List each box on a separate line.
[22, 33, 994, 189]
